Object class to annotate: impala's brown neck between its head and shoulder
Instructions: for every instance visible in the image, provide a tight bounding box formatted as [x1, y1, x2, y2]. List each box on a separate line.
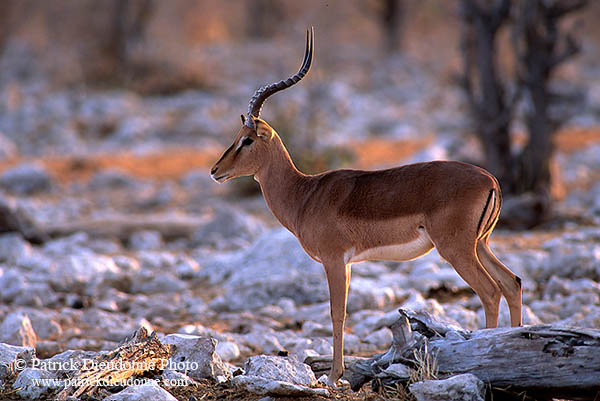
[254, 135, 310, 233]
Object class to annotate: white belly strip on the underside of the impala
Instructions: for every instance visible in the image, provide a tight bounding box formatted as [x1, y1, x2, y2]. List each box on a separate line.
[344, 230, 433, 263]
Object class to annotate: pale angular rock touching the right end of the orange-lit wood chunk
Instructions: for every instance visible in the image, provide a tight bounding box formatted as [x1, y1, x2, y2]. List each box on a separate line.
[161, 334, 229, 380]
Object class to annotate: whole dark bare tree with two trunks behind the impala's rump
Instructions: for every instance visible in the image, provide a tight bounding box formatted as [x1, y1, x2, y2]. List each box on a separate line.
[460, 0, 587, 227]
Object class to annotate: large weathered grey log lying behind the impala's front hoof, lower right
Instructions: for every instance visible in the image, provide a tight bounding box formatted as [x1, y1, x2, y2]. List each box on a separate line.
[305, 309, 600, 399]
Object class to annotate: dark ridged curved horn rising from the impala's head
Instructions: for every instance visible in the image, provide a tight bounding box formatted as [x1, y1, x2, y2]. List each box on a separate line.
[246, 27, 315, 128]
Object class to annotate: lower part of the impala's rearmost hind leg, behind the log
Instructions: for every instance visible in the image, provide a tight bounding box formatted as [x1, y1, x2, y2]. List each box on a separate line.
[477, 235, 523, 327]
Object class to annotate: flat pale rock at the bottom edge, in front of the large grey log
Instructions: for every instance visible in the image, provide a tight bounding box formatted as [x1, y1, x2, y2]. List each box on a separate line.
[408, 373, 485, 401]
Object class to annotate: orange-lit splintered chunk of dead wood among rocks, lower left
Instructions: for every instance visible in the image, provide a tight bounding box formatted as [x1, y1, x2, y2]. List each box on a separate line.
[56, 327, 171, 400]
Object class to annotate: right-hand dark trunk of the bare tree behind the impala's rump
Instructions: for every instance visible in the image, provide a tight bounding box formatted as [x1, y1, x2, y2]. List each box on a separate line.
[513, 0, 587, 196]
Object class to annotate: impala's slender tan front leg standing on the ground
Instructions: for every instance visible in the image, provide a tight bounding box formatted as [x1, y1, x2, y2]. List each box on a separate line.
[323, 258, 350, 386]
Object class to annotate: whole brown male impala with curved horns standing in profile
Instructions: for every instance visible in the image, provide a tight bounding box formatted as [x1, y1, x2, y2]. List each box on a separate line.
[211, 30, 521, 385]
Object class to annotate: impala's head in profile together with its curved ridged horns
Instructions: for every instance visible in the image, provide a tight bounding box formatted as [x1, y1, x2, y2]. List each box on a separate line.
[210, 28, 314, 182]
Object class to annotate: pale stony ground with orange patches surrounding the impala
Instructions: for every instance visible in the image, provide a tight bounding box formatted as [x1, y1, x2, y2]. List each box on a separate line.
[0, 48, 600, 400]
